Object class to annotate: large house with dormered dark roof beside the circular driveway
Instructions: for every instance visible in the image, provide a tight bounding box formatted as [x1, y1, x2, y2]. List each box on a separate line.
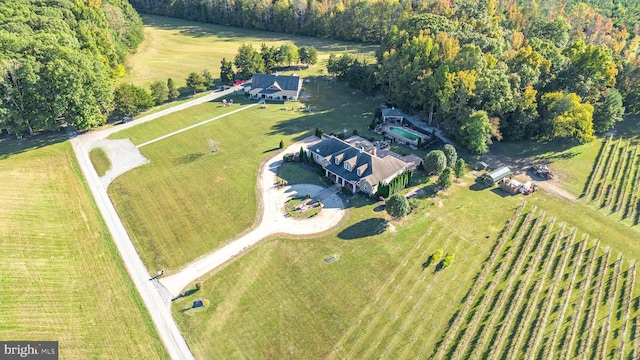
[308, 134, 410, 195]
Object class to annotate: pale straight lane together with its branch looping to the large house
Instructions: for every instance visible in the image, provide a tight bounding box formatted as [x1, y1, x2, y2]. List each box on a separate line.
[70, 88, 343, 359]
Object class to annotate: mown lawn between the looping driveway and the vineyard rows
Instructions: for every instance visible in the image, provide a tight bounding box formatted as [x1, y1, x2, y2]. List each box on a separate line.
[174, 164, 640, 359]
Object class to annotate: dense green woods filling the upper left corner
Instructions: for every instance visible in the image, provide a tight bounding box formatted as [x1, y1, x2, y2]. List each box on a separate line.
[0, 0, 143, 135]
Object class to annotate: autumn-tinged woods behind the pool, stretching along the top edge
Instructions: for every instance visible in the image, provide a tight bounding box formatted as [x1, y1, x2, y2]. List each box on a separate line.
[132, 0, 640, 151]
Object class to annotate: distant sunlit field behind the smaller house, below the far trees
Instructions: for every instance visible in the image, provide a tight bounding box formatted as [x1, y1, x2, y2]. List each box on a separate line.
[122, 15, 375, 86]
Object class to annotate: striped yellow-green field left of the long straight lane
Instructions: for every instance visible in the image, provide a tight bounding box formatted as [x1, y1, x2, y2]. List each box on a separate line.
[0, 134, 168, 359]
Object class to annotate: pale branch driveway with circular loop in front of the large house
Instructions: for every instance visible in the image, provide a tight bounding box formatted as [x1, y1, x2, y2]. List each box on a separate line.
[160, 138, 344, 297]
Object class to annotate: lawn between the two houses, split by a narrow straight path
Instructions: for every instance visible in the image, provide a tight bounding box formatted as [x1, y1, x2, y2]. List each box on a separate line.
[109, 78, 382, 272]
